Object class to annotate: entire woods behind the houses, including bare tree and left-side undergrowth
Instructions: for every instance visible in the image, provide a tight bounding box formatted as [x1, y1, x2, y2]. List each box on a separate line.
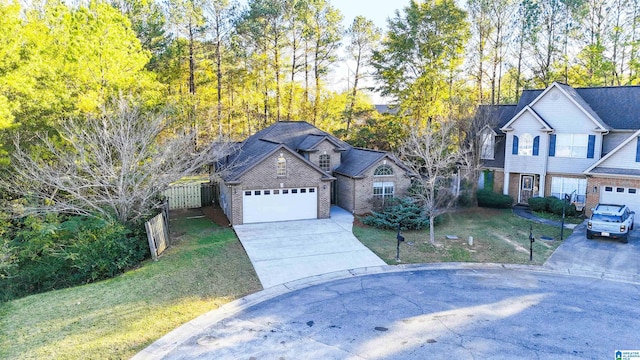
[0, 0, 640, 301]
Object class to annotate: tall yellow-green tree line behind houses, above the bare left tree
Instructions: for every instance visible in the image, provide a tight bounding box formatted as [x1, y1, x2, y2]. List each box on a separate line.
[0, 0, 640, 152]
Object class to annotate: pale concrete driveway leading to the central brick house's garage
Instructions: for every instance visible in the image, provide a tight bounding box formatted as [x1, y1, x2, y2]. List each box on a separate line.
[234, 206, 385, 288]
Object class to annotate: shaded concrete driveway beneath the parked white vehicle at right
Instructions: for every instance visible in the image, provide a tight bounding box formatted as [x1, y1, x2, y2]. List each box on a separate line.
[544, 221, 640, 282]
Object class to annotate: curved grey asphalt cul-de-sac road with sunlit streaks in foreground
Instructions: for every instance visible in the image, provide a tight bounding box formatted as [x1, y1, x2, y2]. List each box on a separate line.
[136, 264, 640, 360]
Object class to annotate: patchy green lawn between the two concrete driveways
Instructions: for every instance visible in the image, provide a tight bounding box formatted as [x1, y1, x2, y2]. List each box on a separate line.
[353, 208, 571, 264]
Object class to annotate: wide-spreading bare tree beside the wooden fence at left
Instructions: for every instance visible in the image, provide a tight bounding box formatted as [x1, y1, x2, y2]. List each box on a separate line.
[5, 99, 232, 223]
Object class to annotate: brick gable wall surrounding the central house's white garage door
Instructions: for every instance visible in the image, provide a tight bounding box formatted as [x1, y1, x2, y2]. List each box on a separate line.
[227, 149, 331, 225]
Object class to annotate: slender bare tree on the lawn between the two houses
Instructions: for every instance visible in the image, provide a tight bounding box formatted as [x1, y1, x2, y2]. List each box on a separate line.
[399, 121, 460, 244]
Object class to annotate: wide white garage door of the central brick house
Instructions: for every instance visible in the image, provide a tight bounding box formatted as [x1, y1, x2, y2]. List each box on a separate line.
[242, 188, 318, 224]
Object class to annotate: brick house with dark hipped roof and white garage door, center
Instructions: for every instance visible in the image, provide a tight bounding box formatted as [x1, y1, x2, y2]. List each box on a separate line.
[219, 121, 412, 225]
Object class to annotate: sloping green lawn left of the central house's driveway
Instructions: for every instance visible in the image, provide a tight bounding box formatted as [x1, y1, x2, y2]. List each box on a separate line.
[0, 214, 261, 359]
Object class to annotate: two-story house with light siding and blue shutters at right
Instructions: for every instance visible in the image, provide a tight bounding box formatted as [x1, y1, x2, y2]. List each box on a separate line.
[480, 83, 640, 217]
